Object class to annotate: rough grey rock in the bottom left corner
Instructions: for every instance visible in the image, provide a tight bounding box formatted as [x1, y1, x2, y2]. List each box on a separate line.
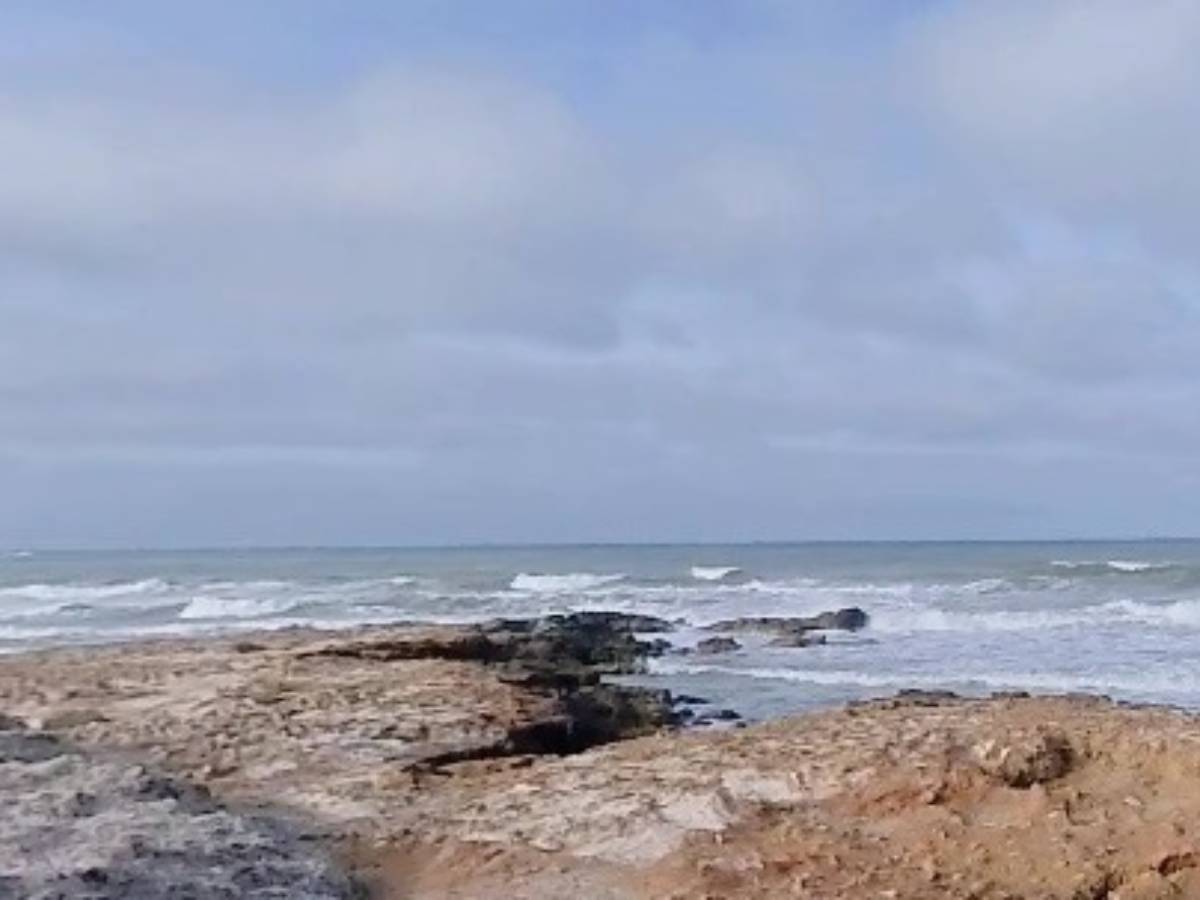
[0, 733, 365, 900]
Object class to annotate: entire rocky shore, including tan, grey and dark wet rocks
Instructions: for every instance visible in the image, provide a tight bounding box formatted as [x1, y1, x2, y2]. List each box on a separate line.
[7, 610, 1200, 900]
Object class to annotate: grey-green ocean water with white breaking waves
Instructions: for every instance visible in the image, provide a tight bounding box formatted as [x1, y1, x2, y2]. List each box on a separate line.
[0, 541, 1200, 718]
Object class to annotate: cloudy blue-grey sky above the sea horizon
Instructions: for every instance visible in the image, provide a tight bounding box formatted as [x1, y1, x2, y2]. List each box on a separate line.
[0, 0, 1200, 547]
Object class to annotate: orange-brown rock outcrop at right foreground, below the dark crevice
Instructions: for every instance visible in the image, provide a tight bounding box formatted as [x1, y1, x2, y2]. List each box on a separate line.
[355, 694, 1200, 900]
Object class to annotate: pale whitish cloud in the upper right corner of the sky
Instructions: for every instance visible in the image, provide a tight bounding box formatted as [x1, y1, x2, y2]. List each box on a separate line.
[907, 0, 1200, 240]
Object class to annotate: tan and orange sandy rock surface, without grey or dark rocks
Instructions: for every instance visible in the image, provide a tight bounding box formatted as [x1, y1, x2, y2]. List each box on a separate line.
[7, 629, 1200, 900]
